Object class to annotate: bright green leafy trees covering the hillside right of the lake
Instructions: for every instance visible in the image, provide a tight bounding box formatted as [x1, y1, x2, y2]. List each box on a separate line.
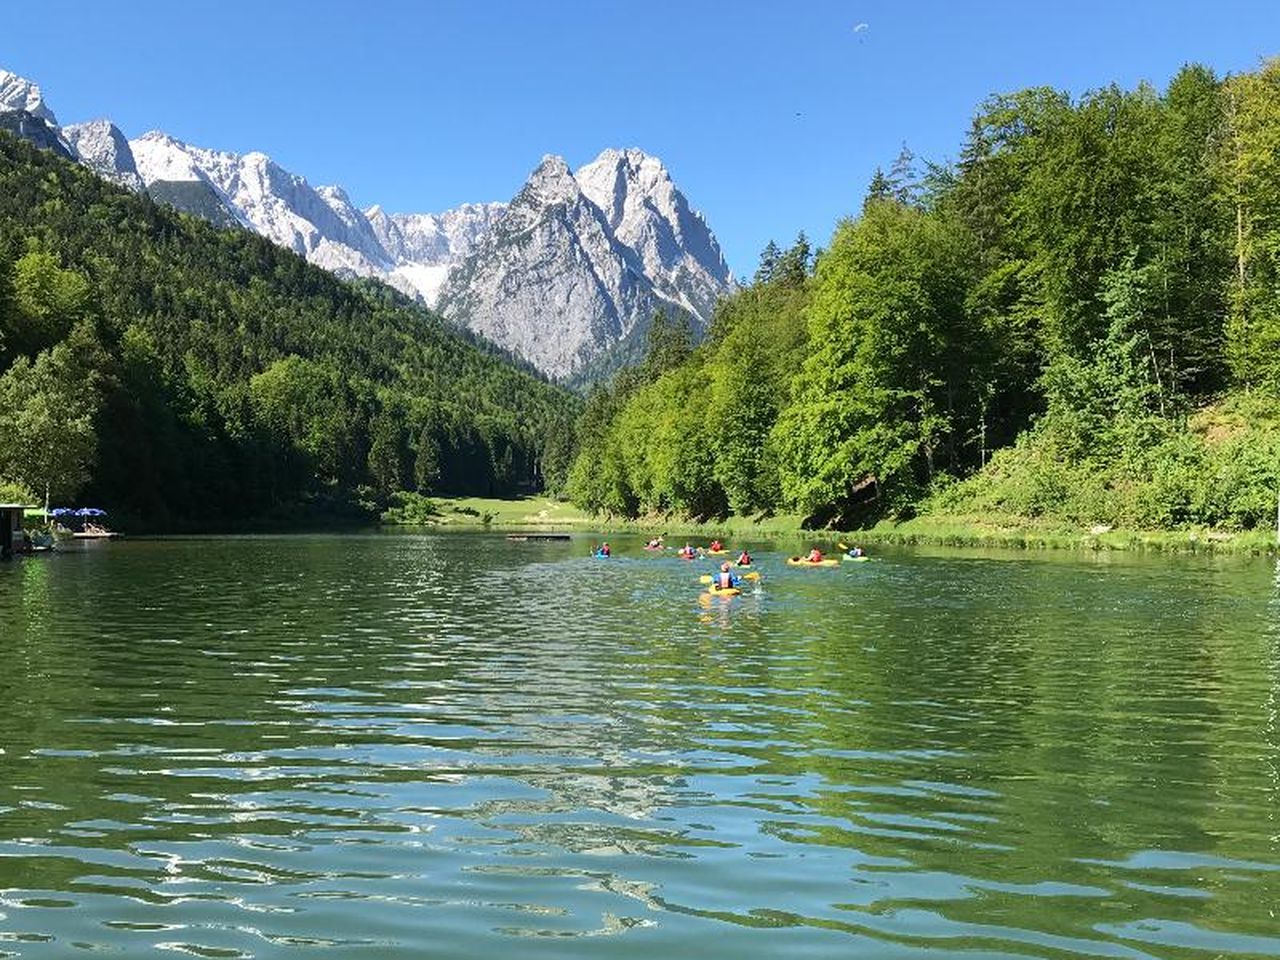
[568, 61, 1280, 529]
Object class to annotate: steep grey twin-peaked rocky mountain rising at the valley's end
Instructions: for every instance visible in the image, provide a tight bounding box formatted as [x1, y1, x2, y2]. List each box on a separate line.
[436, 150, 733, 378]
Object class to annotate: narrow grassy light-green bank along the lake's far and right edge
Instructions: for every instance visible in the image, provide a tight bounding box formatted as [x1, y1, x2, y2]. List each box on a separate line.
[383, 497, 1280, 557]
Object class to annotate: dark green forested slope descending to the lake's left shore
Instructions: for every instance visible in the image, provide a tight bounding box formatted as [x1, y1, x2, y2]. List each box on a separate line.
[0, 133, 577, 530]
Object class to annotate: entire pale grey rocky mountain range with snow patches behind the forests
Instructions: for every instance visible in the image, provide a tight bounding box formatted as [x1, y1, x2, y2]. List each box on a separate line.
[0, 64, 733, 378]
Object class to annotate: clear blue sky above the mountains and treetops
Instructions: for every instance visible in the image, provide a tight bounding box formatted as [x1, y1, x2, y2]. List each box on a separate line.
[0, 0, 1280, 274]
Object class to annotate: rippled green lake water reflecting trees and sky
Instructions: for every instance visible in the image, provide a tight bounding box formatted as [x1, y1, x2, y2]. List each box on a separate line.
[0, 534, 1280, 959]
